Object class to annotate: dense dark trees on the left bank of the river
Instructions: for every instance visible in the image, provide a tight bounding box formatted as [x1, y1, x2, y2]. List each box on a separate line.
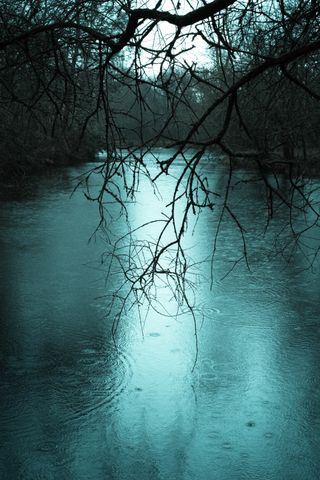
[0, 1, 109, 182]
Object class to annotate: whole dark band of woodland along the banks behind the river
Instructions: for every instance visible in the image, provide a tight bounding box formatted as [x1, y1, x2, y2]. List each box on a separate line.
[0, 0, 320, 183]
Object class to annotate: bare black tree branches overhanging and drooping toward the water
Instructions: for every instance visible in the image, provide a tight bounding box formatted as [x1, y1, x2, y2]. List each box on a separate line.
[0, 0, 320, 360]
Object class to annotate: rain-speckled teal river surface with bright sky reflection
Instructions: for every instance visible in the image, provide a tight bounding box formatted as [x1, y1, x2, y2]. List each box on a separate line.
[0, 158, 320, 480]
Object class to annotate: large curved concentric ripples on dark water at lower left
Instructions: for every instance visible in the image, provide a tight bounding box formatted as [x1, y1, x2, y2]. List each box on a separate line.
[0, 342, 132, 436]
